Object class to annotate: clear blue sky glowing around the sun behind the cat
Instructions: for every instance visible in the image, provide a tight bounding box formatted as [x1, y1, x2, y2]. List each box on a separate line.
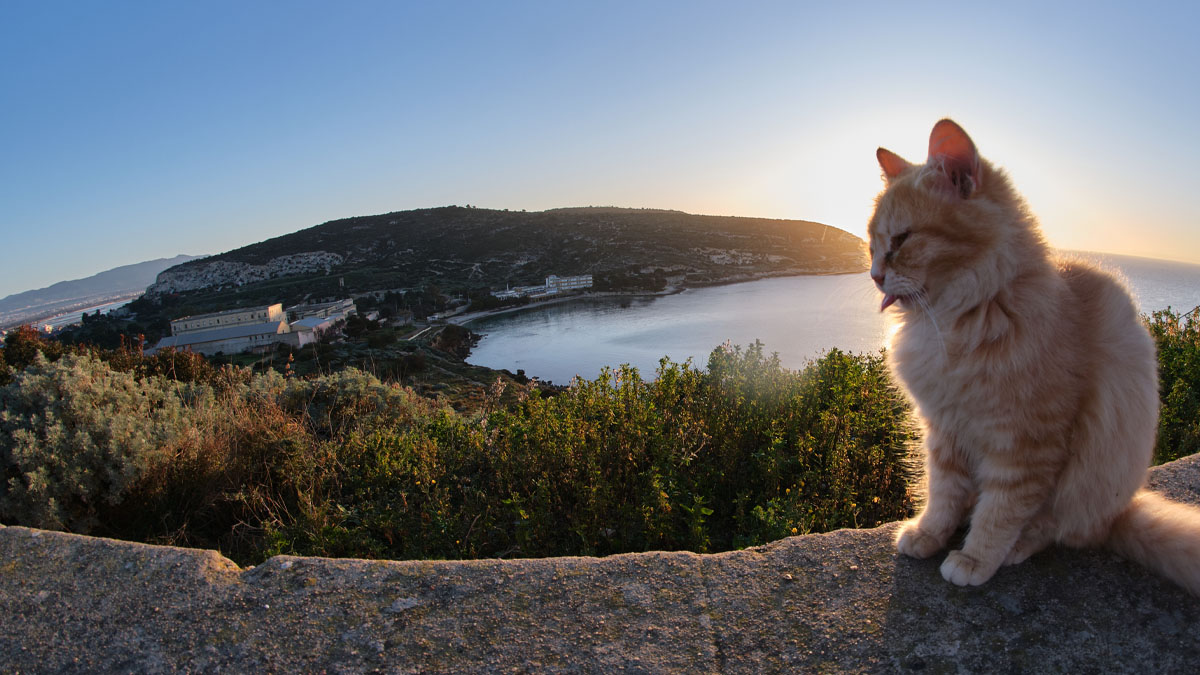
[0, 0, 1200, 297]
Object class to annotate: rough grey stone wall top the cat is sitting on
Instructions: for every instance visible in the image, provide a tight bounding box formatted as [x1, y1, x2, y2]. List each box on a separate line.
[0, 456, 1200, 673]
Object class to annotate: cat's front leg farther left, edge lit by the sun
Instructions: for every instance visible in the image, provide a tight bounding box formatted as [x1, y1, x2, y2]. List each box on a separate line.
[896, 432, 974, 558]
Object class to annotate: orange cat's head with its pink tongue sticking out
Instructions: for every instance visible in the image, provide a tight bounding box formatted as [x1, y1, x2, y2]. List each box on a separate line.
[868, 119, 1044, 311]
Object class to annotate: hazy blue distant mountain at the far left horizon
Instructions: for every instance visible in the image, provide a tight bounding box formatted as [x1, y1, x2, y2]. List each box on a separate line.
[0, 256, 203, 325]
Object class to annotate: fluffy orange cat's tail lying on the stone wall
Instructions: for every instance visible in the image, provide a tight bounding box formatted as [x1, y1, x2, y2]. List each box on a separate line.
[1108, 490, 1200, 597]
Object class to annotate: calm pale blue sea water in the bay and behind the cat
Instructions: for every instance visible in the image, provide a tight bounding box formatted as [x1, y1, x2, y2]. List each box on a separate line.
[467, 253, 1200, 384]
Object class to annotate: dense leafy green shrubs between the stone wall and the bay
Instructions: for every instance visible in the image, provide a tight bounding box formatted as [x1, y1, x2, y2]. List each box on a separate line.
[270, 345, 913, 557]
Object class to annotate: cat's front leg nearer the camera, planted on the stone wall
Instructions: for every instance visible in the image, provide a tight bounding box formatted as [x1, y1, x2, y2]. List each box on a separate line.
[941, 462, 1049, 586]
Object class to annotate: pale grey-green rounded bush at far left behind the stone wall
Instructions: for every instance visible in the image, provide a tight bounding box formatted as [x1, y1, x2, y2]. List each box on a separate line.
[0, 352, 188, 532]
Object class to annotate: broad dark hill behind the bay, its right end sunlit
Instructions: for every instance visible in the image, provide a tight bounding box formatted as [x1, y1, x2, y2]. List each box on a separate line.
[148, 207, 865, 304]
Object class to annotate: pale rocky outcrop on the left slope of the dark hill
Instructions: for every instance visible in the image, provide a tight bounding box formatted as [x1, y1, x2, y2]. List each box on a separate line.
[146, 251, 344, 297]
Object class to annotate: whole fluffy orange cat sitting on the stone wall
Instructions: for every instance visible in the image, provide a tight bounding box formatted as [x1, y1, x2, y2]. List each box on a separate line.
[869, 120, 1200, 596]
